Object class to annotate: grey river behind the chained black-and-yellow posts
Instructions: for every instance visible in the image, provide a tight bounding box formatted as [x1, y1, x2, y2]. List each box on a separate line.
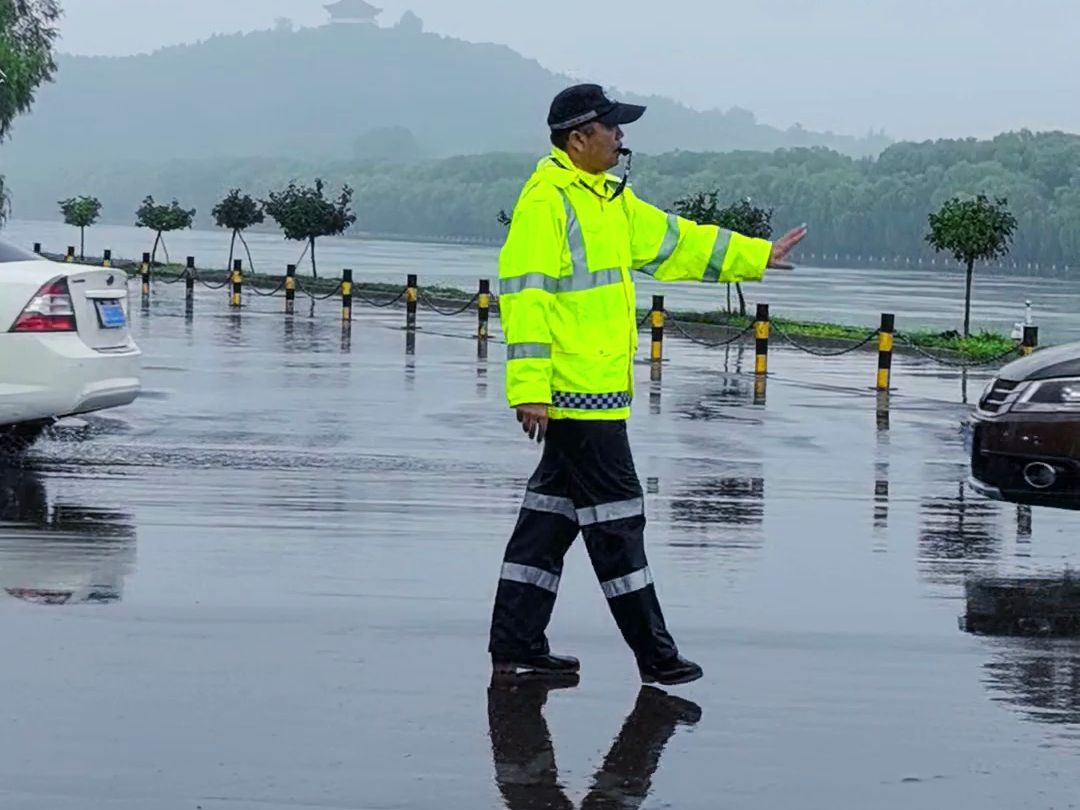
[3, 220, 1080, 343]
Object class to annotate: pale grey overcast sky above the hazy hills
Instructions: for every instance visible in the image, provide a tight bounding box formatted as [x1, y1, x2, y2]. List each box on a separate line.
[54, 0, 1080, 139]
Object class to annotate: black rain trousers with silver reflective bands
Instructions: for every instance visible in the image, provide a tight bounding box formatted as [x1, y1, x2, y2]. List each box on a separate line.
[488, 419, 677, 664]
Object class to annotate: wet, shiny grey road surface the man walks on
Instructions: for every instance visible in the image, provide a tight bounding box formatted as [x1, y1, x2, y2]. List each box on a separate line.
[0, 288, 1080, 810]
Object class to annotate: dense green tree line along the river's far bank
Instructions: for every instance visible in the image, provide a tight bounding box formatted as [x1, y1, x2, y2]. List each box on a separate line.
[21, 132, 1080, 273]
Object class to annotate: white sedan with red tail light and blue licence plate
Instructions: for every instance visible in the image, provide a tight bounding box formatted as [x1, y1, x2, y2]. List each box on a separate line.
[0, 241, 141, 453]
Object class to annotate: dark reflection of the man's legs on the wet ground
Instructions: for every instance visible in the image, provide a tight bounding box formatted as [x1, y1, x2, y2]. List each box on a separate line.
[487, 680, 701, 810]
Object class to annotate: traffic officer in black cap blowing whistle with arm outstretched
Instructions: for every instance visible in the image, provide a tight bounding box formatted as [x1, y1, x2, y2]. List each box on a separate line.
[488, 84, 806, 684]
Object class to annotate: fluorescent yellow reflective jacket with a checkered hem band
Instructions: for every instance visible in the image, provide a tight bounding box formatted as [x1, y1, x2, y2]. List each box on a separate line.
[499, 148, 772, 419]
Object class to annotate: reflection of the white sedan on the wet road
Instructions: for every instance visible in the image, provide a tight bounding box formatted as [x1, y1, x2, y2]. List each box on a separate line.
[0, 469, 135, 605]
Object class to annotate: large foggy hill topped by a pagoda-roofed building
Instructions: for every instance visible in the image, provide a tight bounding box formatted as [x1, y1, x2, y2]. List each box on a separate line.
[3, 18, 888, 168]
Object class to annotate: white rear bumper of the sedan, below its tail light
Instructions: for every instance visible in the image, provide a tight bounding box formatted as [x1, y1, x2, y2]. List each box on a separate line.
[0, 333, 143, 424]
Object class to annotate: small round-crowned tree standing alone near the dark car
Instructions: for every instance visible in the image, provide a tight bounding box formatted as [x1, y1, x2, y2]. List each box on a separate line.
[926, 194, 1016, 337]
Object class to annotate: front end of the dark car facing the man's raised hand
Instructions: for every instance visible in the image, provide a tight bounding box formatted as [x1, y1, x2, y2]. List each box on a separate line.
[970, 342, 1080, 510]
